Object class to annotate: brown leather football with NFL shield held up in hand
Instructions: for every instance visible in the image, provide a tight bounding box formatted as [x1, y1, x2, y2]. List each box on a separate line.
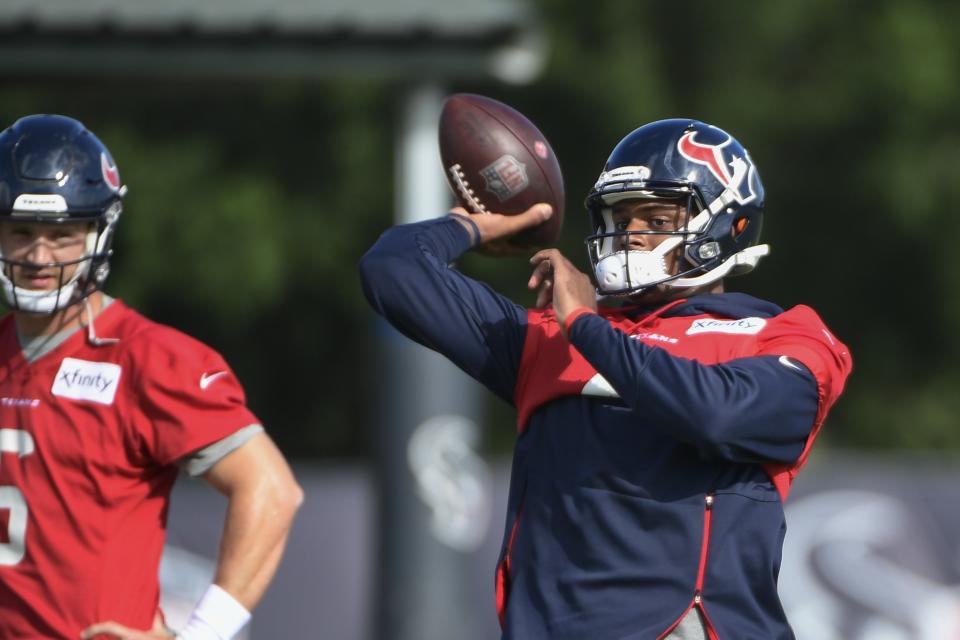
[439, 93, 564, 249]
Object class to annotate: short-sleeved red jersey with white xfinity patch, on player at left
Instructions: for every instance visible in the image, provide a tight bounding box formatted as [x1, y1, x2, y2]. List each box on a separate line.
[0, 300, 259, 640]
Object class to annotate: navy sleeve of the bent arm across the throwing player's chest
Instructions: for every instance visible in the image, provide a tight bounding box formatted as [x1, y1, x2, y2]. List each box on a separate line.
[569, 314, 840, 463]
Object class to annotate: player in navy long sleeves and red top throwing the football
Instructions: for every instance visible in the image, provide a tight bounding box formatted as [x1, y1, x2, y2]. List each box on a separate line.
[360, 119, 852, 640]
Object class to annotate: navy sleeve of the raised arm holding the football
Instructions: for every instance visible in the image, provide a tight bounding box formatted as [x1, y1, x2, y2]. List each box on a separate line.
[360, 217, 527, 403]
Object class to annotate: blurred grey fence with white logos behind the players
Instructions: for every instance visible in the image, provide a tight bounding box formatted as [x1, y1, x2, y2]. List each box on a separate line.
[162, 454, 960, 640]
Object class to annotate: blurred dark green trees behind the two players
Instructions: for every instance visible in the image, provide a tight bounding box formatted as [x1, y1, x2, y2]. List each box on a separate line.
[0, 0, 960, 458]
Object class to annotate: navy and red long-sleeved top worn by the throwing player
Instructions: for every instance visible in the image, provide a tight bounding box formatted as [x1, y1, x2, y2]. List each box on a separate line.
[360, 218, 850, 640]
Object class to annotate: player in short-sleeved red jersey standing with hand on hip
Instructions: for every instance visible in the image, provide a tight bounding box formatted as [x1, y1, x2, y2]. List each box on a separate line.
[0, 115, 302, 640]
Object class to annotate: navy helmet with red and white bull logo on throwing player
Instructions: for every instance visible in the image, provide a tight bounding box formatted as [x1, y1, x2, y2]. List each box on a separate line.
[586, 119, 769, 295]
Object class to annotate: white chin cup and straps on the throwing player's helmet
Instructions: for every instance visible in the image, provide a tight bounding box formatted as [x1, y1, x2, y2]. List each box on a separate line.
[594, 189, 770, 293]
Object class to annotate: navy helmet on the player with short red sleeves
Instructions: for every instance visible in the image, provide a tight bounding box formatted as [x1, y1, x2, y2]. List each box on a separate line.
[0, 115, 127, 313]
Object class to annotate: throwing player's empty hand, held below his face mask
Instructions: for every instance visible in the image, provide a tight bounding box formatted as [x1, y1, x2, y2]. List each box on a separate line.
[527, 249, 597, 327]
